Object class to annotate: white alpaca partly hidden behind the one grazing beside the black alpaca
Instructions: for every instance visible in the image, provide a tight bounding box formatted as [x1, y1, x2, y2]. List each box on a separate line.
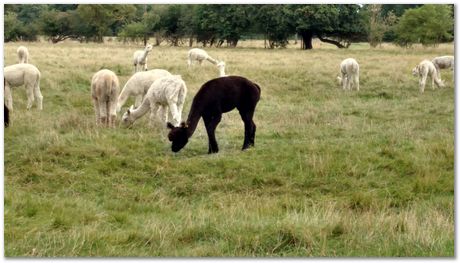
[117, 69, 171, 113]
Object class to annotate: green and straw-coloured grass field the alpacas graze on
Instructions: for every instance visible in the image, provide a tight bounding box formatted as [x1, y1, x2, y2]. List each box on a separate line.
[4, 42, 455, 257]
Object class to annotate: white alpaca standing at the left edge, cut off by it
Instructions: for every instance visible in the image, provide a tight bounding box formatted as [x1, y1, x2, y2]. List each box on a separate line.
[3, 64, 43, 111]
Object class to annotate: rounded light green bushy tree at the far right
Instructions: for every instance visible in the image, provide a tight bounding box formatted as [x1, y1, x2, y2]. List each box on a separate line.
[395, 5, 454, 47]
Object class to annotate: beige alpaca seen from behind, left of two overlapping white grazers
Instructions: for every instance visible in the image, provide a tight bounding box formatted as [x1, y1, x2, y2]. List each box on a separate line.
[91, 69, 120, 127]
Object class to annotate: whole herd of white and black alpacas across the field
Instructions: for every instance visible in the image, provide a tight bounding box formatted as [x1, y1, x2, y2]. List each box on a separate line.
[4, 44, 454, 153]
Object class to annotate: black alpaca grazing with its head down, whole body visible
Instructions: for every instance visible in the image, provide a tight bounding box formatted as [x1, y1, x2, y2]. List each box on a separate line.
[168, 76, 260, 153]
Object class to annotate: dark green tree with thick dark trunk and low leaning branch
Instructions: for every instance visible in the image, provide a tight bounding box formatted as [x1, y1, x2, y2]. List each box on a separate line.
[295, 4, 366, 49]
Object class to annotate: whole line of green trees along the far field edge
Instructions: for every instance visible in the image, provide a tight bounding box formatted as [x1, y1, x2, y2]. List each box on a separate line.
[4, 4, 454, 49]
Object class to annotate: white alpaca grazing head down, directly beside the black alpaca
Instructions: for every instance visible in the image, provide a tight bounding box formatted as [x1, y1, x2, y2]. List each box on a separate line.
[122, 75, 187, 127]
